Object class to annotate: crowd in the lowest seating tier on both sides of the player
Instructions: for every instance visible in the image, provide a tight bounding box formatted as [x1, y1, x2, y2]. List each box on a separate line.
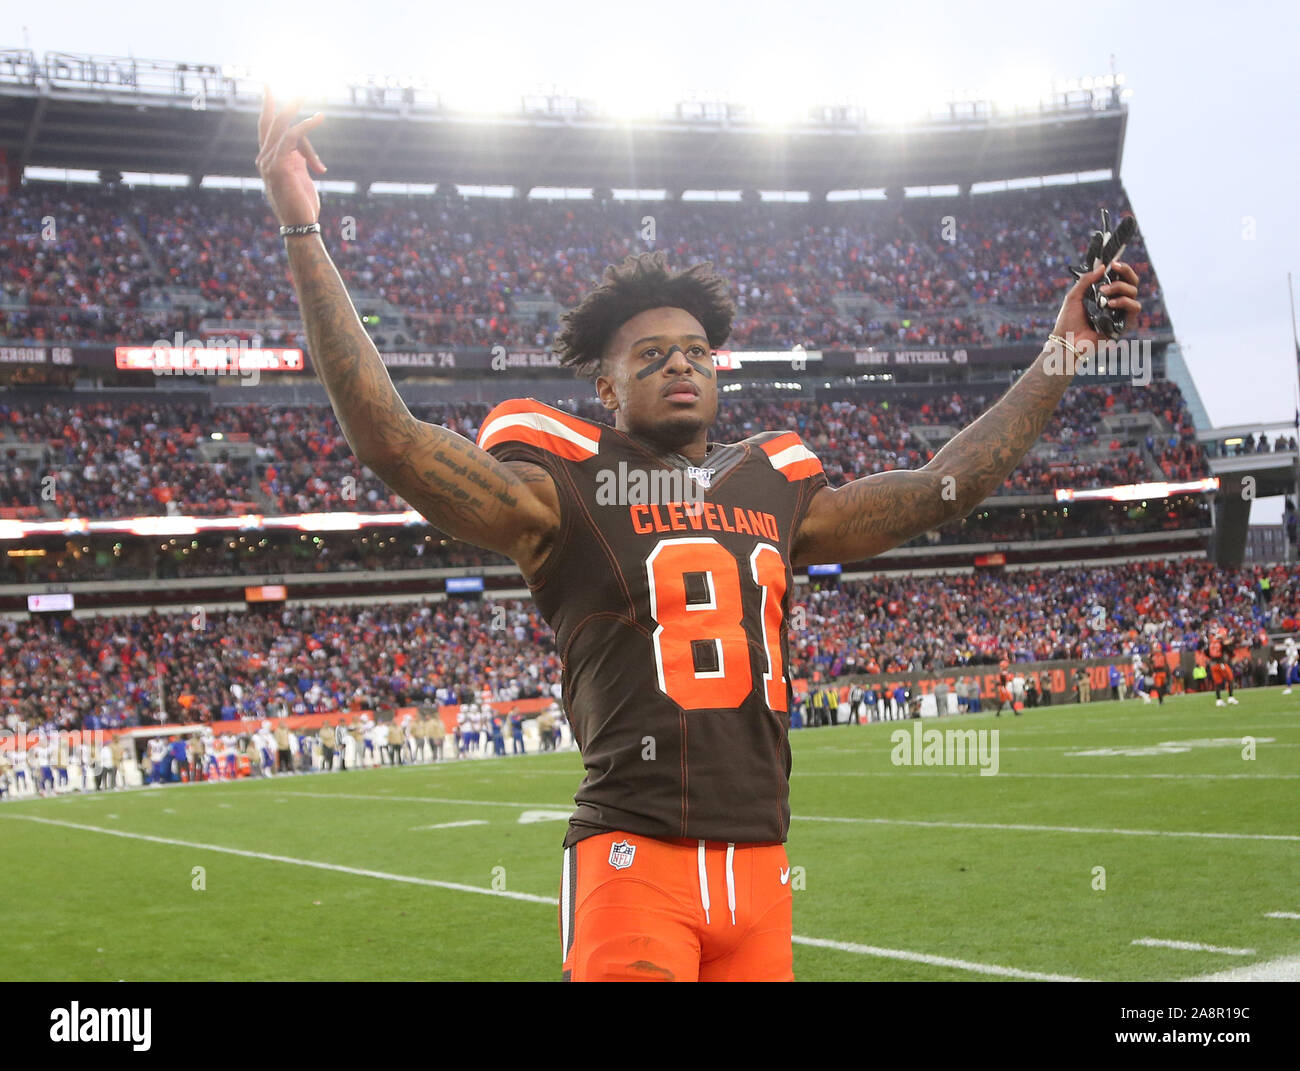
[0, 559, 1300, 728]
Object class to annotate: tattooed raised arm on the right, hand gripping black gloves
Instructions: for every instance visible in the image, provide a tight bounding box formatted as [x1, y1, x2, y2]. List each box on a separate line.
[790, 261, 1141, 565]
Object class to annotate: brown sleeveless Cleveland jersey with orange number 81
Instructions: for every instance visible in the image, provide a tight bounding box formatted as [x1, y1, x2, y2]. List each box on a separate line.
[478, 399, 827, 847]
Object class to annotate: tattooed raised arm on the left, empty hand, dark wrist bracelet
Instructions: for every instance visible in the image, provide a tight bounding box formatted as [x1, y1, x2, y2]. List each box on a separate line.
[257, 91, 559, 576]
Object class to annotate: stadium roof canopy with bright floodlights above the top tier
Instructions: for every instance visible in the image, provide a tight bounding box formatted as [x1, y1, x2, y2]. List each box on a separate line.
[0, 49, 1127, 198]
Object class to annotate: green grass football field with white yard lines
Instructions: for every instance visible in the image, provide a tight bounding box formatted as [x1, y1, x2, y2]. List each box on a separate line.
[0, 689, 1300, 980]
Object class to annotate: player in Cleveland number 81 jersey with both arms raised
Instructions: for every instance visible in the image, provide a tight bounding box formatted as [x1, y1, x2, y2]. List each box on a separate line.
[257, 91, 1140, 980]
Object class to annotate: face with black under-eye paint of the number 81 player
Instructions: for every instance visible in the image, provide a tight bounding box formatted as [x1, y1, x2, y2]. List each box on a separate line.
[595, 308, 718, 450]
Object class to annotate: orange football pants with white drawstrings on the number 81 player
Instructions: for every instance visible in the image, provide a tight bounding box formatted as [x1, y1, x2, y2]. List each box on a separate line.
[560, 832, 794, 981]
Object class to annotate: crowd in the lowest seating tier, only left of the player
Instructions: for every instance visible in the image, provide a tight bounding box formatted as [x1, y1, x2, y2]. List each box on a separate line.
[0, 599, 560, 728]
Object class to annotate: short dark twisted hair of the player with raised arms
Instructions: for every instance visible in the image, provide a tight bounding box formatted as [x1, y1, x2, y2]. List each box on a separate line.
[555, 250, 736, 382]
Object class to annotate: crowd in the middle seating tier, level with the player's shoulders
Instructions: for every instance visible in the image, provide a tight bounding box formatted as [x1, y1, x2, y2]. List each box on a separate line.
[0, 380, 1208, 517]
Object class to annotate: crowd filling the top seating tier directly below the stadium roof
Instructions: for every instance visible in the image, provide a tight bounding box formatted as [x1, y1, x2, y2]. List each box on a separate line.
[0, 182, 1167, 348]
